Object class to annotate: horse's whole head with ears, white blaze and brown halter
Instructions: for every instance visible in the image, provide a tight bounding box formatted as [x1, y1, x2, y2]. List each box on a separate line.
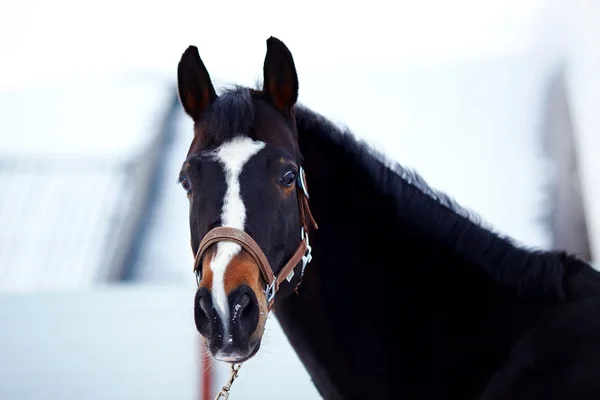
[177, 37, 316, 363]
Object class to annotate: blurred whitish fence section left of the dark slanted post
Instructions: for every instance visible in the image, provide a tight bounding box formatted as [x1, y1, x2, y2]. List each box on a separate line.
[0, 156, 133, 291]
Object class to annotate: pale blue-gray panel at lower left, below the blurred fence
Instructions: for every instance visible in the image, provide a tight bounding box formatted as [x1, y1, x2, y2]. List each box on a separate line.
[0, 286, 200, 400]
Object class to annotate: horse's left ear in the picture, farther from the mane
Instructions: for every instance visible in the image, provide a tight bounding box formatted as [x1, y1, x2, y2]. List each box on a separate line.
[177, 46, 217, 121]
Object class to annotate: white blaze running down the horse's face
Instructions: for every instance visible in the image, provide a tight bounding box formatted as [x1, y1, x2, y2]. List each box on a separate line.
[210, 137, 265, 341]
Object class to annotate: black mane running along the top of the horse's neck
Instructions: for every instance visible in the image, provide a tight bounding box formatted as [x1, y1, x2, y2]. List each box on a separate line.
[296, 106, 584, 299]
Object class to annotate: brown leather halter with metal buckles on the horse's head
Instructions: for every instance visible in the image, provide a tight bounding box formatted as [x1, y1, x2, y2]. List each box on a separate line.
[194, 168, 319, 310]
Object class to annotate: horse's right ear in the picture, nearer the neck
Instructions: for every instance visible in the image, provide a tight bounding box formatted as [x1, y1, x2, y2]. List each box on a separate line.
[263, 36, 298, 112]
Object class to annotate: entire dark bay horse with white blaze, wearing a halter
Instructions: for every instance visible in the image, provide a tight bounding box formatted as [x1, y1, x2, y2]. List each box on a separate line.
[177, 37, 600, 400]
